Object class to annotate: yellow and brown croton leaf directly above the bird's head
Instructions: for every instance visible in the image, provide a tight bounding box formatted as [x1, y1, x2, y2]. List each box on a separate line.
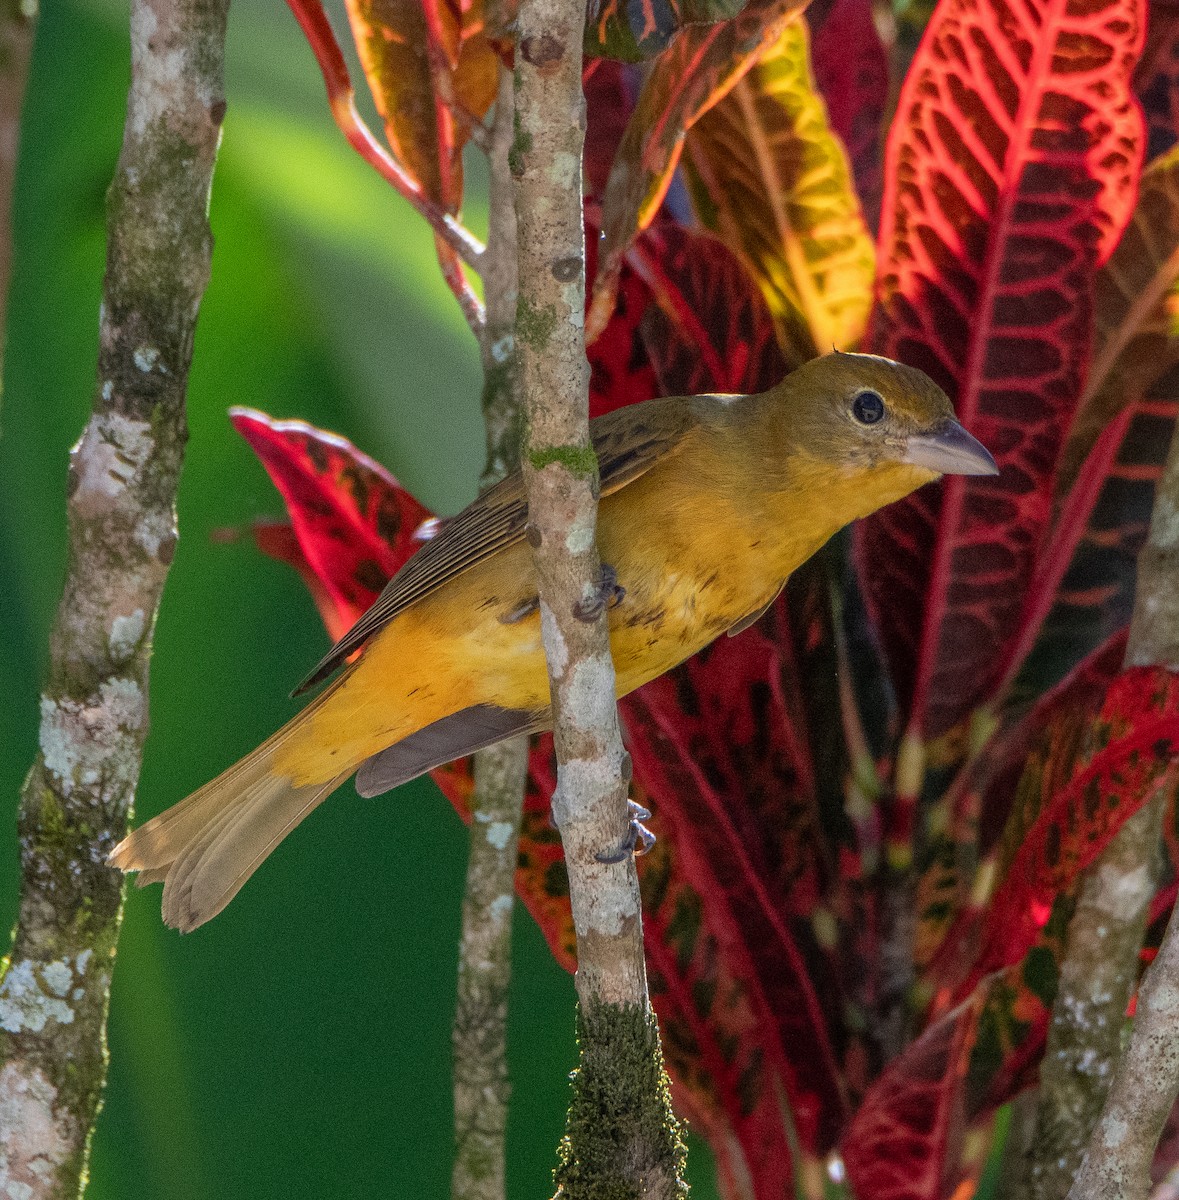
[684, 17, 875, 365]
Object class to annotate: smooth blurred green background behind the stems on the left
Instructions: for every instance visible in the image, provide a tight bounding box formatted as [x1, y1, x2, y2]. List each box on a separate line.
[0, 0, 714, 1200]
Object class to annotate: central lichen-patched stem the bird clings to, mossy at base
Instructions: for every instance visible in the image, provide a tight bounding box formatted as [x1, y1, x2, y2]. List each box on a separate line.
[510, 0, 687, 1198]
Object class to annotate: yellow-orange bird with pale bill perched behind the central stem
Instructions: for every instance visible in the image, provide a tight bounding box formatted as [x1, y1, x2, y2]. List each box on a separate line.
[110, 354, 997, 931]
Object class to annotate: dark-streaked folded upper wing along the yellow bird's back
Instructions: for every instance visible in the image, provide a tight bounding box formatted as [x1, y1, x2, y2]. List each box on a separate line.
[294, 396, 696, 696]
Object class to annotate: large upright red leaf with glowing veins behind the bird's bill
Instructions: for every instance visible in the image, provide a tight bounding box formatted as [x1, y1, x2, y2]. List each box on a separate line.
[857, 0, 1144, 739]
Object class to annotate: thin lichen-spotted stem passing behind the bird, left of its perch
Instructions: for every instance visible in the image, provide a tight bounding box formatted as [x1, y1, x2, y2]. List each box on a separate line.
[450, 68, 528, 1200]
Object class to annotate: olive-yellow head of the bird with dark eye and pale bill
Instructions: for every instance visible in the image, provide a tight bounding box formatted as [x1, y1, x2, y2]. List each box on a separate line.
[779, 352, 999, 494]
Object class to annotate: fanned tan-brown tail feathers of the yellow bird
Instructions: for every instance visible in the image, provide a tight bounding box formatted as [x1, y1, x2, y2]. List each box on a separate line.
[108, 706, 352, 934]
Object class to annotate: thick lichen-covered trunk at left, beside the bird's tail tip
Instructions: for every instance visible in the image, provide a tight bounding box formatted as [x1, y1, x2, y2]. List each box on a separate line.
[0, 0, 227, 1200]
